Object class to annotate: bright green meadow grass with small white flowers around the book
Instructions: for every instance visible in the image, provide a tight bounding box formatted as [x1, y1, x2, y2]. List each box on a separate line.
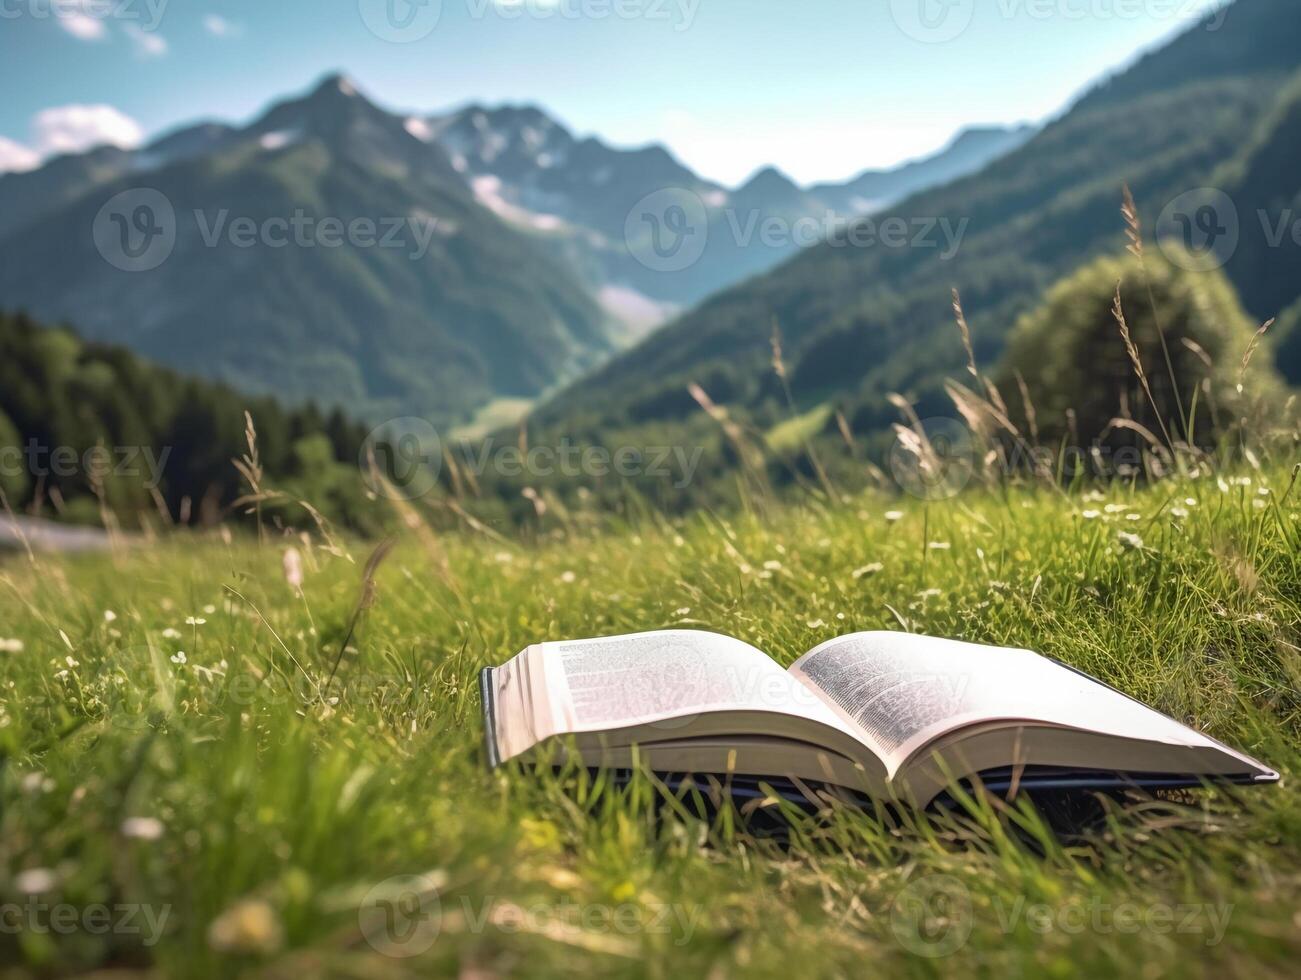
[0, 469, 1301, 977]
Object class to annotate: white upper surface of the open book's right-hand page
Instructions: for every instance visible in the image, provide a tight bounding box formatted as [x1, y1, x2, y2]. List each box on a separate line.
[791, 633, 1233, 773]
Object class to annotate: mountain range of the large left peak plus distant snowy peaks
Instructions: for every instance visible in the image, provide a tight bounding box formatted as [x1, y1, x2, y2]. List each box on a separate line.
[0, 75, 1024, 420]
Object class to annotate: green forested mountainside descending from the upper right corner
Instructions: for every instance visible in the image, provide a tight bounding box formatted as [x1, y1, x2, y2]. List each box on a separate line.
[535, 0, 1301, 440]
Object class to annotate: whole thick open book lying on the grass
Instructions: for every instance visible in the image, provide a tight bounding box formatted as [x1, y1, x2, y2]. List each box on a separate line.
[480, 630, 1278, 806]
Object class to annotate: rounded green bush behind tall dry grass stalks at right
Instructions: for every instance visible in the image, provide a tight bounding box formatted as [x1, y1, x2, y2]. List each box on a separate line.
[998, 254, 1279, 446]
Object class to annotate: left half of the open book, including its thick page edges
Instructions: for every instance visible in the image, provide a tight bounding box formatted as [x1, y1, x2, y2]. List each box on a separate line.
[485, 630, 886, 795]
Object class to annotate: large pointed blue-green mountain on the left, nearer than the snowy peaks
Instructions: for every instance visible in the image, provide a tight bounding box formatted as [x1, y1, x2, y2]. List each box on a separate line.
[0, 75, 615, 419]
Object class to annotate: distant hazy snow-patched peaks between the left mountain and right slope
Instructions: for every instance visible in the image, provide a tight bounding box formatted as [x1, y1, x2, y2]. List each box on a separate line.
[419, 104, 1030, 315]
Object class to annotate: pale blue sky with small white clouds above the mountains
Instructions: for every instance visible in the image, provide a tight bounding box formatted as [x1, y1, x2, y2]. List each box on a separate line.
[0, 0, 1232, 184]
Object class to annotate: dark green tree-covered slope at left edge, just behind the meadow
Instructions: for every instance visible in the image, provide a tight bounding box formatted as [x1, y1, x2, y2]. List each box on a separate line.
[0, 314, 366, 527]
